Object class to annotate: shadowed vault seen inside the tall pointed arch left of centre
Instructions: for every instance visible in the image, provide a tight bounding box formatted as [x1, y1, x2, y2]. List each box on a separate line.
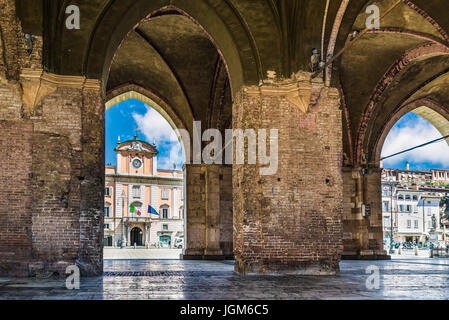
[107, 10, 232, 129]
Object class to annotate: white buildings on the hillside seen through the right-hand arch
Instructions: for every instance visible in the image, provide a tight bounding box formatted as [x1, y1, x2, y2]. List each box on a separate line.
[382, 165, 449, 244]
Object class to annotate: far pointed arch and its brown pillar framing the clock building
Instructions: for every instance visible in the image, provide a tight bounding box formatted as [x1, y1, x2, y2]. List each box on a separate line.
[105, 84, 234, 260]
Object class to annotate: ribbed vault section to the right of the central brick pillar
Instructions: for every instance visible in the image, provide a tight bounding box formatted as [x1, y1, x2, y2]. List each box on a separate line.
[338, 0, 449, 163]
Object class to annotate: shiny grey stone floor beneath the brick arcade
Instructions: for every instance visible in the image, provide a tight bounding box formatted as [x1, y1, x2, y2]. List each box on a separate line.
[0, 256, 449, 300]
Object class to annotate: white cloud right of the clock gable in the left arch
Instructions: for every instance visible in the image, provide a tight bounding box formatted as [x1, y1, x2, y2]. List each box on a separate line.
[132, 106, 183, 169]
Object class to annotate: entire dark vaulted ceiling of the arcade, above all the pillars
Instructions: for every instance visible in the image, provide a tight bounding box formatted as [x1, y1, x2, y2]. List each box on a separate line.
[17, 0, 449, 165]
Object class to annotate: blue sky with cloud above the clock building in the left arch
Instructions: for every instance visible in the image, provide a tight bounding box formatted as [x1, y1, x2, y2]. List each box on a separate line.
[106, 99, 183, 169]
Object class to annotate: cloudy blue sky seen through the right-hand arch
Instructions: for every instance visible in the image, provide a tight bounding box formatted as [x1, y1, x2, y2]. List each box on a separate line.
[382, 112, 449, 170]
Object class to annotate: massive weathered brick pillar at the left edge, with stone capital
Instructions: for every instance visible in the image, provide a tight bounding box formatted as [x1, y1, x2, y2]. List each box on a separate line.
[0, 0, 104, 276]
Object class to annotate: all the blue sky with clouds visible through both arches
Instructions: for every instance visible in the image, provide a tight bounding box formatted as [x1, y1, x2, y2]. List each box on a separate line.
[106, 99, 449, 174]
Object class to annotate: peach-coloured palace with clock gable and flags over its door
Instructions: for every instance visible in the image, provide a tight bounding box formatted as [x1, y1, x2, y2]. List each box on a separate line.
[104, 137, 184, 248]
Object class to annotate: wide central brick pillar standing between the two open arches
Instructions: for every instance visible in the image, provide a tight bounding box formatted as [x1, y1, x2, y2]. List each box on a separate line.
[233, 75, 343, 274]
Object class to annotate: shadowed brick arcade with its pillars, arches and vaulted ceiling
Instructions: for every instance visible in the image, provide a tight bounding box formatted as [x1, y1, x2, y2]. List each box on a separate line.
[0, 0, 449, 275]
